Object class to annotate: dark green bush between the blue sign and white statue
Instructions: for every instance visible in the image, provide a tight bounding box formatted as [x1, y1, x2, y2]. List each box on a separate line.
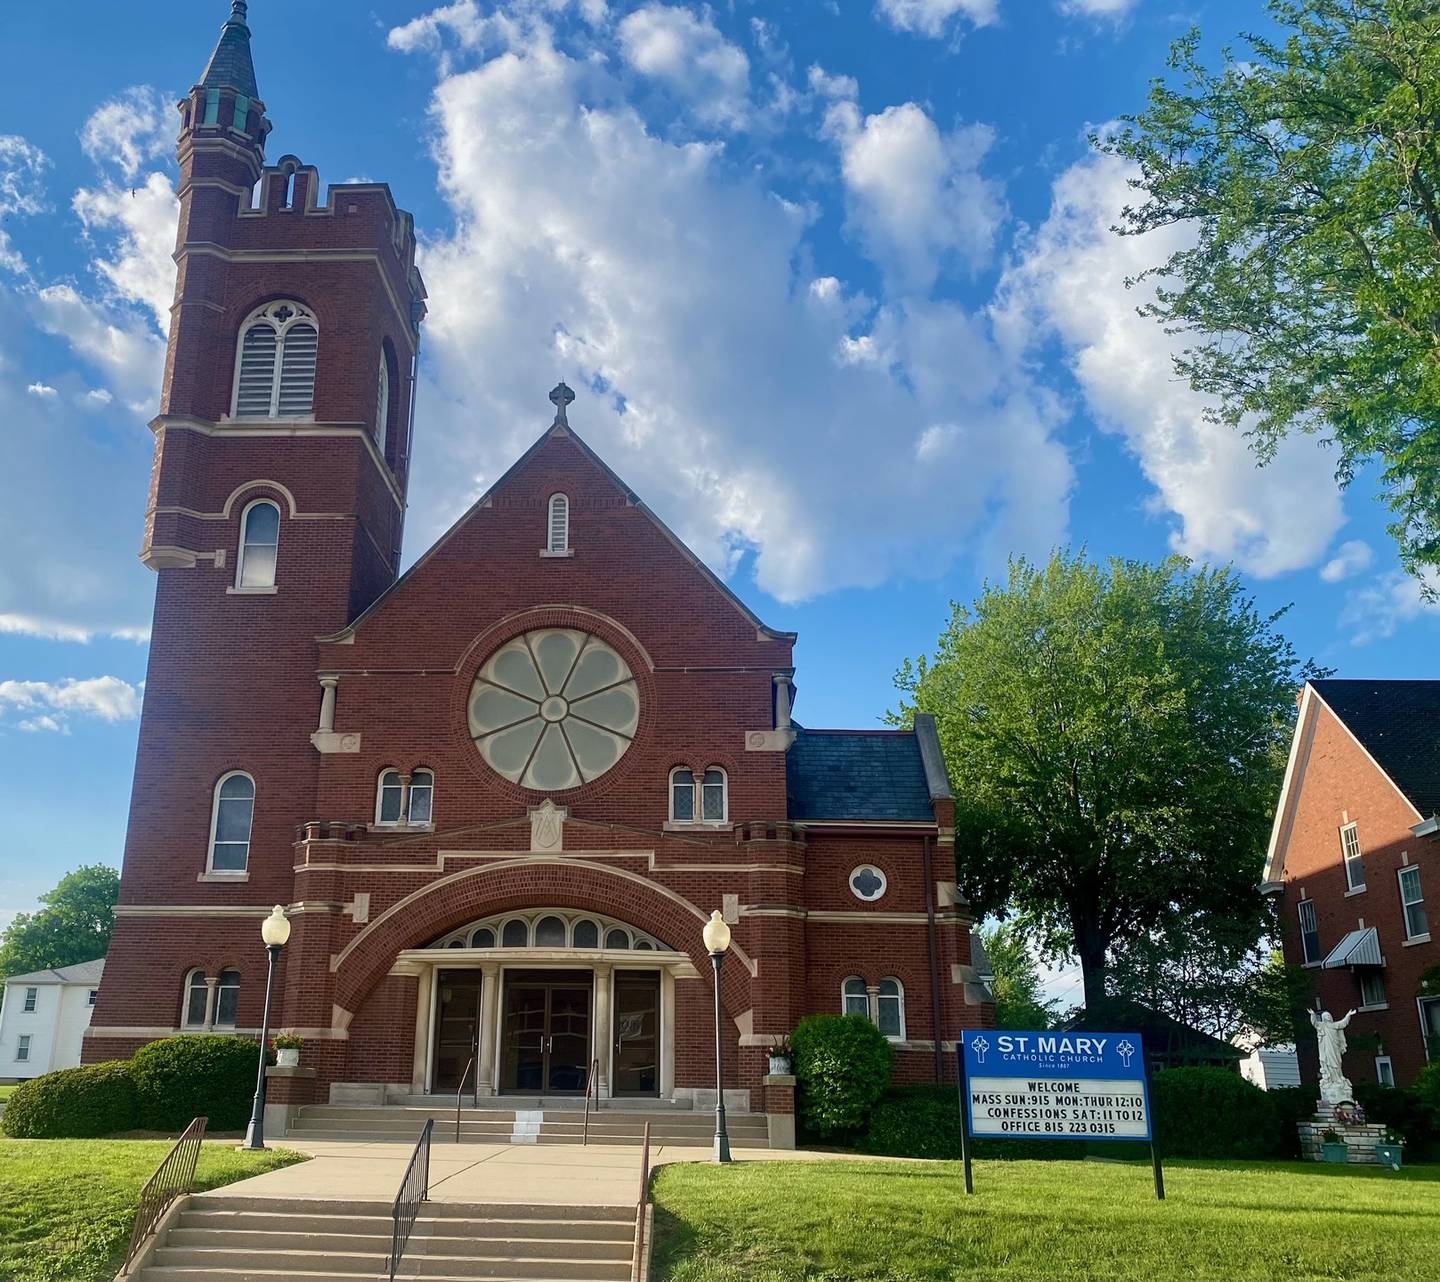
[1151, 1069, 1282, 1158]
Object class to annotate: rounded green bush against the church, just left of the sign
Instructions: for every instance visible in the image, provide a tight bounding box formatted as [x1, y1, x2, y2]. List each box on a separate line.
[792, 1016, 894, 1139]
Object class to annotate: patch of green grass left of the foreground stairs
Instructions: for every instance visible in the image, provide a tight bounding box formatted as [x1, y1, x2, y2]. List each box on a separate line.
[0, 1139, 304, 1282]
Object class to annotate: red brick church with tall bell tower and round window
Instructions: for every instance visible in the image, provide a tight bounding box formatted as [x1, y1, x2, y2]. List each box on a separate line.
[85, 0, 992, 1129]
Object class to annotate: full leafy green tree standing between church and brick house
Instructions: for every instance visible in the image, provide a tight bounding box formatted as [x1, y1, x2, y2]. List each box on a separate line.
[893, 553, 1308, 1005]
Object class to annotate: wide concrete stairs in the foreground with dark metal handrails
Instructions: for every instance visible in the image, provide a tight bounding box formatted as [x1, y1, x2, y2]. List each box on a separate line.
[127, 1194, 635, 1282]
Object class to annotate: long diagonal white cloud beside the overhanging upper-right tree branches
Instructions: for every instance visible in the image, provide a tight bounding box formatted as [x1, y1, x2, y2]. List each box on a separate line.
[995, 146, 1344, 576]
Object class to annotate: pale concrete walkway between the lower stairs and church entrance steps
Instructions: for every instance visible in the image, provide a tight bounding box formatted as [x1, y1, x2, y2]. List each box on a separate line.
[207, 1138, 848, 1206]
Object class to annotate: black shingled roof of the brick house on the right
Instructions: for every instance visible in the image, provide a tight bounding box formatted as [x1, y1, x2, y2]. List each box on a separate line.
[1310, 678, 1440, 818]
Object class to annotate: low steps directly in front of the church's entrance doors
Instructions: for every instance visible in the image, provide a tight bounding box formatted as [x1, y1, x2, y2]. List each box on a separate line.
[285, 1103, 769, 1148]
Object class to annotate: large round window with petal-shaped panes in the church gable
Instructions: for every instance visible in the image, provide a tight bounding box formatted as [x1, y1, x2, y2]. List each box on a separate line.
[469, 628, 639, 792]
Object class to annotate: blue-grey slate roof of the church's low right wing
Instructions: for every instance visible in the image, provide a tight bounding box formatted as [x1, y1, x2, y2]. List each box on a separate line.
[785, 730, 935, 824]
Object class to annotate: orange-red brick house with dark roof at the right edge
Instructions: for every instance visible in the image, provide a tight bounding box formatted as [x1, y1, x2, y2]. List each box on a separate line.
[1264, 680, 1440, 1086]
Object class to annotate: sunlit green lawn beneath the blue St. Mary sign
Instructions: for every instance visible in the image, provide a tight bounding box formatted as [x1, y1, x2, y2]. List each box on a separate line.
[652, 1161, 1440, 1282]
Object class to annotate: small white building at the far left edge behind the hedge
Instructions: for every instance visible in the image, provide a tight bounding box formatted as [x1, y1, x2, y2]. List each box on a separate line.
[0, 958, 105, 1082]
